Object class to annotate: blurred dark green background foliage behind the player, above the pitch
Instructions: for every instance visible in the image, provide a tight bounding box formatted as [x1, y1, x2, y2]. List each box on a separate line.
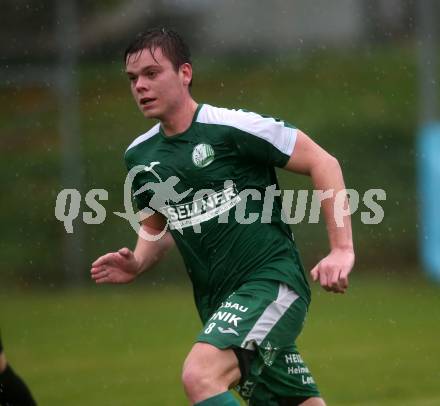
[0, 0, 434, 286]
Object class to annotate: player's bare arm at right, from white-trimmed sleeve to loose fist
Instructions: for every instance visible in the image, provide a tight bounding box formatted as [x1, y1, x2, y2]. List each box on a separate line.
[285, 131, 354, 293]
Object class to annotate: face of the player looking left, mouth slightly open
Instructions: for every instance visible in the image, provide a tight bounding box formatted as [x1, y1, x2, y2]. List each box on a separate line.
[126, 48, 192, 121]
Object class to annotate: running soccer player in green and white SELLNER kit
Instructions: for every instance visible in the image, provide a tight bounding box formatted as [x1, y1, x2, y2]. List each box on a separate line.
[91, 28, 354, 406]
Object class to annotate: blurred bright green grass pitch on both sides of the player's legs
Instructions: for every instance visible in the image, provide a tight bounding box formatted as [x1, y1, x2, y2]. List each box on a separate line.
[0, 270, 440, 406]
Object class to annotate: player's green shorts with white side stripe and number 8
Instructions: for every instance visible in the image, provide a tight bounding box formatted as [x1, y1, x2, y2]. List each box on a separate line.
[197, 280, 320, 406]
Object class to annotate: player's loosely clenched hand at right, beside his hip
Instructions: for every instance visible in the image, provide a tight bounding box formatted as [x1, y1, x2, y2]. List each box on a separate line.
[310, 248, 354, 293]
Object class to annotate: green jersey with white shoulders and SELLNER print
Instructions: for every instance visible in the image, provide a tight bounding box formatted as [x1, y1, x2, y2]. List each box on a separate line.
[125, 104, 310, 322]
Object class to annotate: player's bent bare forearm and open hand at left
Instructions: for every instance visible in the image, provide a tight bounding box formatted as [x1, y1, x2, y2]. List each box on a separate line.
[90, 213, 174, 283]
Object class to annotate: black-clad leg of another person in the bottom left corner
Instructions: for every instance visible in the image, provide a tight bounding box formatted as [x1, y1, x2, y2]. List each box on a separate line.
[0, 337, 36, 406]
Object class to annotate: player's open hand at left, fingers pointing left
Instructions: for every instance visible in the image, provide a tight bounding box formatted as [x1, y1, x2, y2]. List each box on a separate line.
[90, 248, 140, 283]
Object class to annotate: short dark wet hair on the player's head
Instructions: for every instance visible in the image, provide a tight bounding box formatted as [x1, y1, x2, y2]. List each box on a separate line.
[124, 27, 192, 86]
